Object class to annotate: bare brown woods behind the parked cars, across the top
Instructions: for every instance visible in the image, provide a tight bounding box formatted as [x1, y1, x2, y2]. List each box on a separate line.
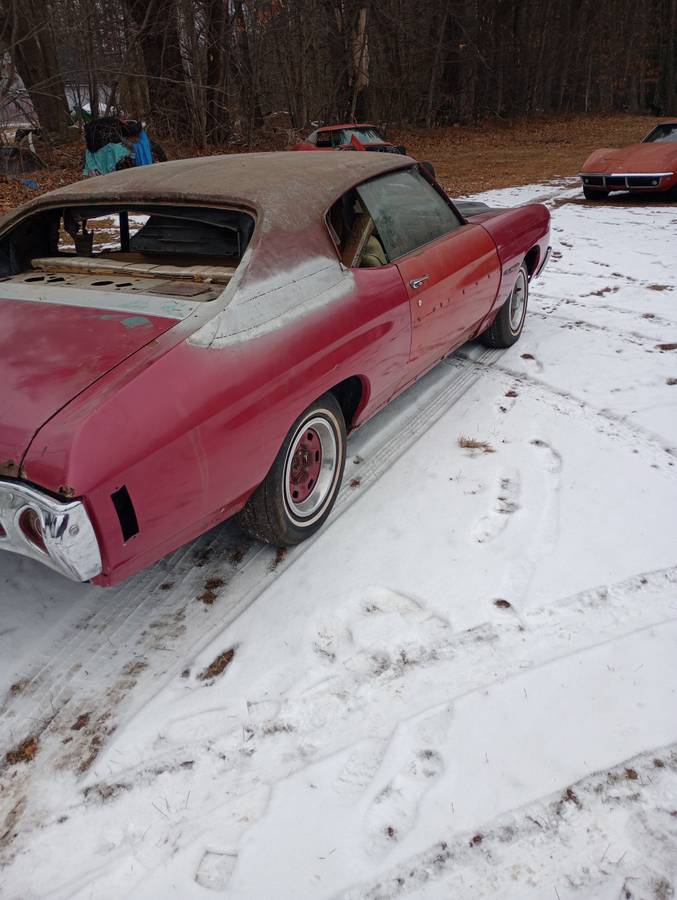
[0, 0, 677, 147]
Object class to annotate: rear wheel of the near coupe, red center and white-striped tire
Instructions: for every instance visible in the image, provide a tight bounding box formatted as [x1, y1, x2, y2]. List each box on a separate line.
[238, 394, 346, 547]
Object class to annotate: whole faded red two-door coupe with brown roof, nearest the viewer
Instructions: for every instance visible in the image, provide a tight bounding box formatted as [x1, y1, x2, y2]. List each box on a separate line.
[0, 153, 549, 584]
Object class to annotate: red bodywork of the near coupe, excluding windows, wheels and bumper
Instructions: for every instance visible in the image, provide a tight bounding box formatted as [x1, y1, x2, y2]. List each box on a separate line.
[0, 153, 549, 584]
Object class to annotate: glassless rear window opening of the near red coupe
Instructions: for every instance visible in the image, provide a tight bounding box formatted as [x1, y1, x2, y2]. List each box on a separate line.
[0, 204, 254, 301]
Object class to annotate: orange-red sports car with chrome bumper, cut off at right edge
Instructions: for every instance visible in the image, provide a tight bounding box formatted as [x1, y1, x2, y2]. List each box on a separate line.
[579, 120, 677, 200]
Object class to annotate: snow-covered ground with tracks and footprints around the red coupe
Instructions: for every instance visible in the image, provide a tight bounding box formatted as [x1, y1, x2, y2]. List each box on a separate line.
[0, 182, 677, 900]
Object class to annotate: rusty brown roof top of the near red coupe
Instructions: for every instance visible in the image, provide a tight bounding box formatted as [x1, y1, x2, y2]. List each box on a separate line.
[0, 151, 414, 227]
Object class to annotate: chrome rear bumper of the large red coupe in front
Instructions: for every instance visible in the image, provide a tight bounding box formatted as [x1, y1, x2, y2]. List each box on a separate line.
[0, 479, 101, 581]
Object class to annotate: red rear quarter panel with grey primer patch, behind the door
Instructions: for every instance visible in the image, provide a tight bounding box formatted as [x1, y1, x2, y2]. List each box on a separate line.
[24, 265, 410, 584]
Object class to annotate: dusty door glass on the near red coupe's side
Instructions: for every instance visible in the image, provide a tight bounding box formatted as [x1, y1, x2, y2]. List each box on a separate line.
[357, 168, 463, 261]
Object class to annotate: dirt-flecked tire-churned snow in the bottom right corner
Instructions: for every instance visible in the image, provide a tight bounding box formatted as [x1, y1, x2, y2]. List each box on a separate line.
[340, 744, 677, 900]
